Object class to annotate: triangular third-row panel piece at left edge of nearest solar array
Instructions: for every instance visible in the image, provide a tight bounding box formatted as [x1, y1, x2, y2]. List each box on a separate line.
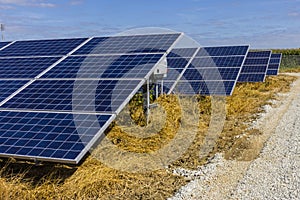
[0, 80, 28, 102]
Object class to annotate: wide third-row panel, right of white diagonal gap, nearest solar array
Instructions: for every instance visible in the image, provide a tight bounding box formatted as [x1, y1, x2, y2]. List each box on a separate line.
[2, 80, 141, 112]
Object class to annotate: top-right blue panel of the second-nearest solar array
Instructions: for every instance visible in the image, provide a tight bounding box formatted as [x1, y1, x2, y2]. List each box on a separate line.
[196, 45, 249, 57]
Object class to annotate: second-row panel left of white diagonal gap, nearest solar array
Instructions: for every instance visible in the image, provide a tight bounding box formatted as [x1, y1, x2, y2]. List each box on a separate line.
[0, 57, 60, 79]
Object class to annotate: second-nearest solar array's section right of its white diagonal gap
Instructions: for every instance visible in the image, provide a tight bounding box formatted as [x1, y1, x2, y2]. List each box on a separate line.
[165, 45, 249, 95]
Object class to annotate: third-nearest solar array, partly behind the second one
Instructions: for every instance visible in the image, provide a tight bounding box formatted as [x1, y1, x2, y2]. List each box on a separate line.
[238, 51, 271, 82]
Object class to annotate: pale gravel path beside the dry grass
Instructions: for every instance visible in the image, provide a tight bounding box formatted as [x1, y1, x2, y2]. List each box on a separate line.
[170, 74, 300, 200]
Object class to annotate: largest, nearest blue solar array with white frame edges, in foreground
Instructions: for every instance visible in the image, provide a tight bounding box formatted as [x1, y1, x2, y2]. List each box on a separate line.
[0, 33, 181, 163]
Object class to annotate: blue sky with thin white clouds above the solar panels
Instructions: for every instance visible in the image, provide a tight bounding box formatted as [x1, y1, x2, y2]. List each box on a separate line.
[0, 0, 300, 48]
